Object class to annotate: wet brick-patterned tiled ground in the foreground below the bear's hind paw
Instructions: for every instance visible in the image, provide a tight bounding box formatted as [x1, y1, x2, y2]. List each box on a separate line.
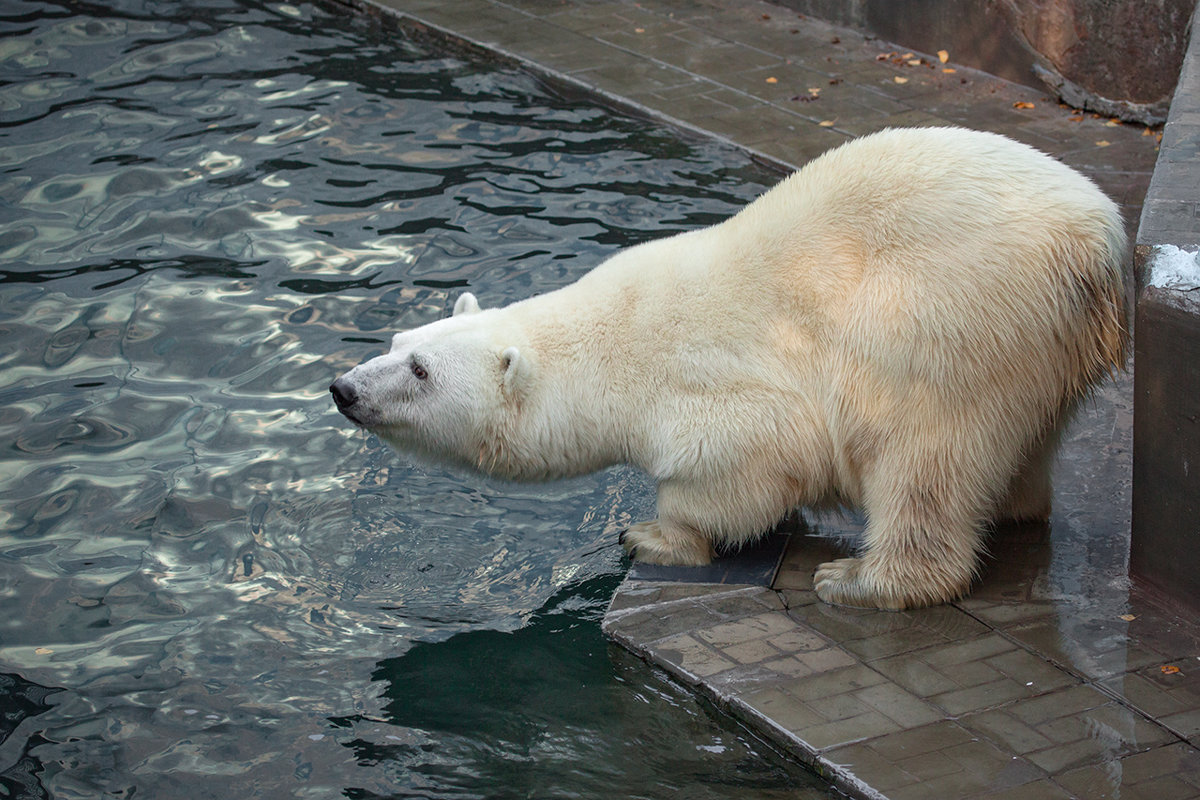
[605, 544, 1200, 800]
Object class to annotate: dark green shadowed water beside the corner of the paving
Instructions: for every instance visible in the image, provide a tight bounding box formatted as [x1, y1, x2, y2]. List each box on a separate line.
[335, 576, 799, 800]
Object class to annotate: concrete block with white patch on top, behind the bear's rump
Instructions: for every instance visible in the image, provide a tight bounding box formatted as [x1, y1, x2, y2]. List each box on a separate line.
[1130, 3, 1200, 602]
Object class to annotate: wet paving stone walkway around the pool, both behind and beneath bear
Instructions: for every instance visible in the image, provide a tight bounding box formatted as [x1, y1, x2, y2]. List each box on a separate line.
[340, 0, 1200, 800]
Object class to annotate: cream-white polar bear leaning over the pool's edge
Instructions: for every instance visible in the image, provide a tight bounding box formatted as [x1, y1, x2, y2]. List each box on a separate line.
[331, 128, 1128, 609]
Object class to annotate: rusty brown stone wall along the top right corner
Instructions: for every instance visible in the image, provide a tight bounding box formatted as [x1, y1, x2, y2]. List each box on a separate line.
[778, 0, 1195, 124]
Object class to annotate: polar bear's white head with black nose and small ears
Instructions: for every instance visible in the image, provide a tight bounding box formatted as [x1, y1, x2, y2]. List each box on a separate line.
[329, 293, 532, 470]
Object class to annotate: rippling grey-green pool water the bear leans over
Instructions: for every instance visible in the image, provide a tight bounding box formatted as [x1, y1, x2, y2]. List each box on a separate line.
[0, 0, 840, 799]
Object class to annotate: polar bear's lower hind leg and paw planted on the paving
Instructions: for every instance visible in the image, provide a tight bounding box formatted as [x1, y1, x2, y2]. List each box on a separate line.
[812, 465, 984, 610]
